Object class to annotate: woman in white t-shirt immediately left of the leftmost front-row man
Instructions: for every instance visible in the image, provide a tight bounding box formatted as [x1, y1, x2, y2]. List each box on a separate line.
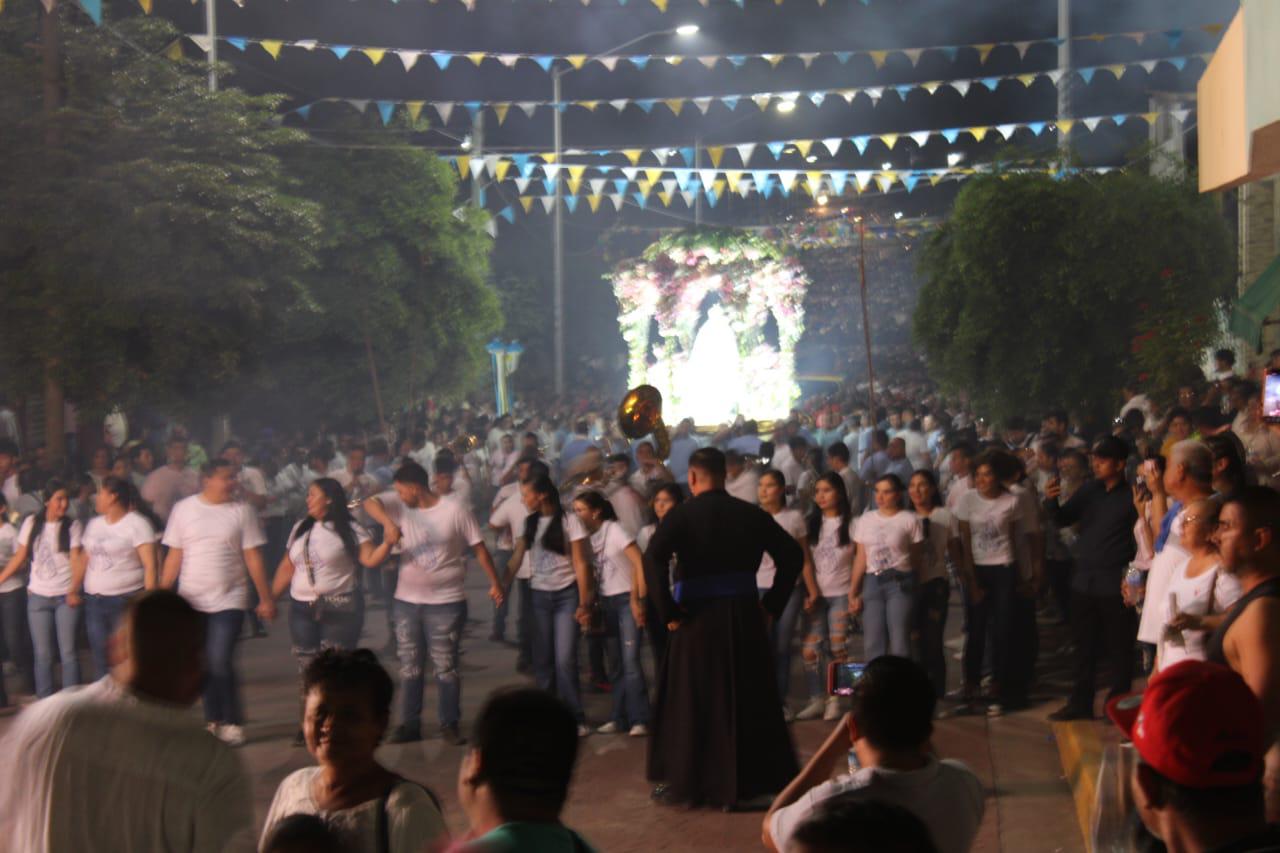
[72, 474, 161, 678]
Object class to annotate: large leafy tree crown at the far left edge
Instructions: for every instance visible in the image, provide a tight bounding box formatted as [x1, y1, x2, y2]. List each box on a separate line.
[0, 3, 319, 432]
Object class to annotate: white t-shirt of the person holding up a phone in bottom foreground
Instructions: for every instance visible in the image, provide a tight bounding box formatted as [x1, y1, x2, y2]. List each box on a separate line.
[769, 753, 984, 853]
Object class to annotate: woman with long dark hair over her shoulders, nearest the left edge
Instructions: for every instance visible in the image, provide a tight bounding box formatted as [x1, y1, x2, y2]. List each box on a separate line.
[0, 480, 84, 699]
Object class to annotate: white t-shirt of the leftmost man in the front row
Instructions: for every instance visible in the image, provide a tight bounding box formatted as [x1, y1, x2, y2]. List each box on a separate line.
[163, 494, 266, 613]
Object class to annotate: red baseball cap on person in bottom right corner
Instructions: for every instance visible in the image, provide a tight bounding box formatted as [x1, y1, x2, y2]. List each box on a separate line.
[1107, 661, 1266, 788]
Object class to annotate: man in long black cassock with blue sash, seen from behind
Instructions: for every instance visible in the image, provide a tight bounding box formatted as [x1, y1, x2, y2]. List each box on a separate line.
[644, 448, 804, 809]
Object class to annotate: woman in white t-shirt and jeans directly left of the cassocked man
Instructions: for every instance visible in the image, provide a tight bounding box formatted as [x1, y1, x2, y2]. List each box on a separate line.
[573, 491, 649, 738]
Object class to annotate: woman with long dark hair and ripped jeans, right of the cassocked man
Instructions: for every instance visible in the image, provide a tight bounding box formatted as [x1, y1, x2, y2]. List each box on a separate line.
[796, 471, 854, 720]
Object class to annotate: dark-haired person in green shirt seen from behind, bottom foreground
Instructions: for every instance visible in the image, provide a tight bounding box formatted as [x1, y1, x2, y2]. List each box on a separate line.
[454, 688, 594, 853]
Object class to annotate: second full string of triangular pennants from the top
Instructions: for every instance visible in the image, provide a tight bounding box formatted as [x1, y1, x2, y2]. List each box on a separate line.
[291, 54, 1211, 126]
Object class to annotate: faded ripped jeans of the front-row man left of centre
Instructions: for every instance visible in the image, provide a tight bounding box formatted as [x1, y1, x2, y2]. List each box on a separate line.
[396, 598, 467, 729]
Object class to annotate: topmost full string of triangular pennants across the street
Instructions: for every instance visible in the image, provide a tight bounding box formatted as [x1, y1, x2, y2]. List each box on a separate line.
[187, 24, 1222, 73]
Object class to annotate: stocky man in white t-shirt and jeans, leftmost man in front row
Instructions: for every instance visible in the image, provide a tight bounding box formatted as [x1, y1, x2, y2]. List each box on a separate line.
[160, 459, 275, 747]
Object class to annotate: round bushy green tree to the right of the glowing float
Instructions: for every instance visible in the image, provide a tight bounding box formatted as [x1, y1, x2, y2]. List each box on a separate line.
[914, 172, 1233, 418]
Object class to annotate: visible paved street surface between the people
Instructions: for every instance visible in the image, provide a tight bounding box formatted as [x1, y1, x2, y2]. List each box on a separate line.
[0, 558, 1083, 853]
